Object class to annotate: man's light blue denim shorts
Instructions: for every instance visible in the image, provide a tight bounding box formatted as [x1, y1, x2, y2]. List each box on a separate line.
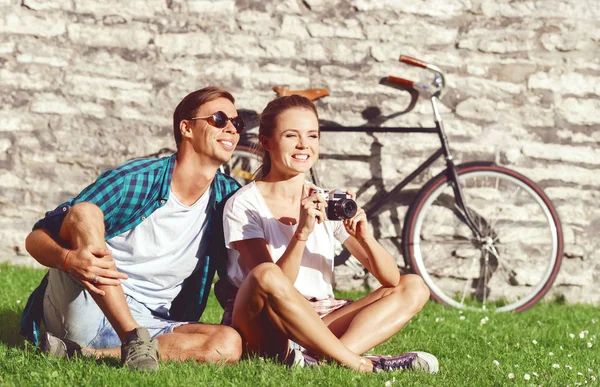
[43, 269, 187, 349]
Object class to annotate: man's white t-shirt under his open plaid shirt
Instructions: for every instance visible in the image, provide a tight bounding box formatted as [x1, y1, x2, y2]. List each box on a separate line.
[106, 189, 210, 315]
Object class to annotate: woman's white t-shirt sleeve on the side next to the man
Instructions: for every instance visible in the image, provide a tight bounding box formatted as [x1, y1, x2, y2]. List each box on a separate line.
[223, 191, 265, 249]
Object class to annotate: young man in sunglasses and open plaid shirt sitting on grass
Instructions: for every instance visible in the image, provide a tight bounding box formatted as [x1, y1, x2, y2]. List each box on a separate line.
[21, 87, 244, 370]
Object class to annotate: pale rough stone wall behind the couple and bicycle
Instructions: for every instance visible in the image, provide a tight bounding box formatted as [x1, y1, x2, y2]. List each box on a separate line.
[0, 0, 600, 303]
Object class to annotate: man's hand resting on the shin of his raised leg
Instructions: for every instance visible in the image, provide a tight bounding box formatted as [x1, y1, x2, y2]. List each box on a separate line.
[65, 246, 128, 296]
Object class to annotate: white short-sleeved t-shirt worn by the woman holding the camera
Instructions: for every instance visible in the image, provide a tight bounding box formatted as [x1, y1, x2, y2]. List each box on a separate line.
[223, 182, 348, 300]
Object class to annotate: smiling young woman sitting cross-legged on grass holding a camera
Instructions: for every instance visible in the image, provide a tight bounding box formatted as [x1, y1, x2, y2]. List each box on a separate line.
[217, 95, 438, 373]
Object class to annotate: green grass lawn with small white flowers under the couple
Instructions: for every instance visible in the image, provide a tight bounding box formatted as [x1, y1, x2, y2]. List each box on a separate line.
[0, 265, 600, 386]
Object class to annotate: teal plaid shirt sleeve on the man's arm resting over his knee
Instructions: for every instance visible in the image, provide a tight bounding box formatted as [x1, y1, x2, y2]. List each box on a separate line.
[33, 170, 123, 241]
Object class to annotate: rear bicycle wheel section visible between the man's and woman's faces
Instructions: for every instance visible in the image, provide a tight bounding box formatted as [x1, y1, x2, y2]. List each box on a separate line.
[223, 136, 262, 186]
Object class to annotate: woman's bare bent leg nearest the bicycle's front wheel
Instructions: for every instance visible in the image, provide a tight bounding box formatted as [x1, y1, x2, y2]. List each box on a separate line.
[323, 274, 429, 354]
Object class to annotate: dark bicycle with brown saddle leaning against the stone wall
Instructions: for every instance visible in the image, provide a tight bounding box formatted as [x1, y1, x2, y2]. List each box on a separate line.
[226, 56, 563, 312]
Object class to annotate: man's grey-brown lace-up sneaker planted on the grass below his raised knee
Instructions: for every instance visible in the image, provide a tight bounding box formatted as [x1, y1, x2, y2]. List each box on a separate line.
[121, 327, 159, 372]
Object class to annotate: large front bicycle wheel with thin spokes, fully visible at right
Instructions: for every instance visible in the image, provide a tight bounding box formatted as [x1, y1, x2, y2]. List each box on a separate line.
[403, 163, 563, 312]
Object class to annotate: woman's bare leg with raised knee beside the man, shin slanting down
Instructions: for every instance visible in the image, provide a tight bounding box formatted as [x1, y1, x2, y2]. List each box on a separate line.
[233, 263, 372, 372]
